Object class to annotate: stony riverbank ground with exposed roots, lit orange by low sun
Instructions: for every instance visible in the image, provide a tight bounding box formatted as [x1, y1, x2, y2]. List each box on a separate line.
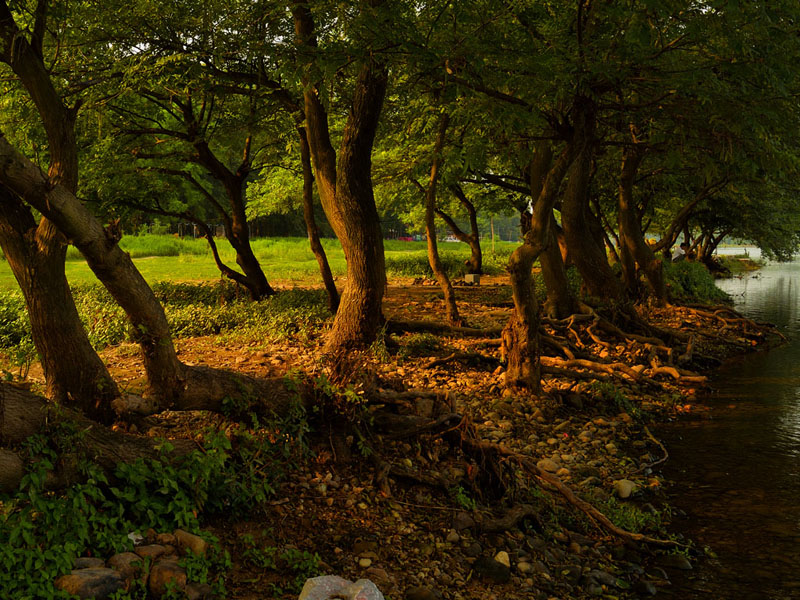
[3, 278, 780, 599]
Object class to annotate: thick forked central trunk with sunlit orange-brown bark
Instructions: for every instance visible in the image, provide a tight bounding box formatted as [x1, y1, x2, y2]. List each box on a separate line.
[292, 1, 388, 354]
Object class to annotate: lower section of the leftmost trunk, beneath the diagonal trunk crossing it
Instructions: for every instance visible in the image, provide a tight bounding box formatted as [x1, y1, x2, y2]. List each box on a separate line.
[0, 190, 119, 423]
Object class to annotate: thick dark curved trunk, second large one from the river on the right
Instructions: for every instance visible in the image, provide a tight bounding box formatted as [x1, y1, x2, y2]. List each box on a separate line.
[561, 98, 624, 305]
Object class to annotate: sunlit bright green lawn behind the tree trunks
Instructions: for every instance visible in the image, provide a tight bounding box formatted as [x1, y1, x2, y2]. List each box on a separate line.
[0, 235, 517, 291]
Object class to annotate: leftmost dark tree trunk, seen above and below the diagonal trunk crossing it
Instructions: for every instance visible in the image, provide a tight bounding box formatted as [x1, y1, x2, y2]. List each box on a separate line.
[0, 10, 117, 421]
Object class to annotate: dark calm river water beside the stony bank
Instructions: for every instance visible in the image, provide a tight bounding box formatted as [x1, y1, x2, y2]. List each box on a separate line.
[662, 262, 800, 600]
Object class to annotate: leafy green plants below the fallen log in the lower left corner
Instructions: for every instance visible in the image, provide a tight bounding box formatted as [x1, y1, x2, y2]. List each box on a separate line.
[0, 411, 310, 598]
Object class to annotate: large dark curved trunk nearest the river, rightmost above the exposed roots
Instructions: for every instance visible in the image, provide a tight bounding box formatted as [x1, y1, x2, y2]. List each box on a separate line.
[619, 148, 667, 306]
